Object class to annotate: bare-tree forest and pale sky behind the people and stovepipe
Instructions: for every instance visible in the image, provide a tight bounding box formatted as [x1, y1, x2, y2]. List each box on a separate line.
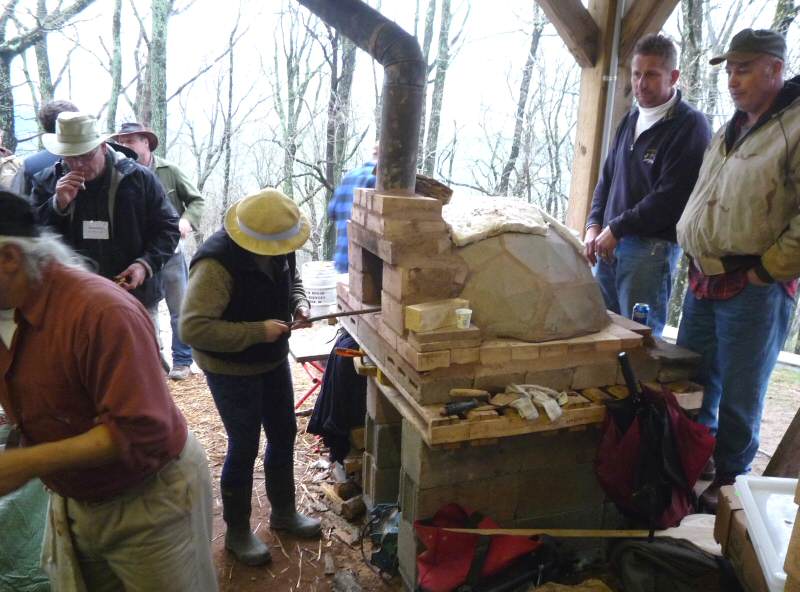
[0, 0, 800, 353]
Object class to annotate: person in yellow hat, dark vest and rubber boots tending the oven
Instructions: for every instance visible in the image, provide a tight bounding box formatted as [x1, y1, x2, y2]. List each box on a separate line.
[180, 189, 320, 565]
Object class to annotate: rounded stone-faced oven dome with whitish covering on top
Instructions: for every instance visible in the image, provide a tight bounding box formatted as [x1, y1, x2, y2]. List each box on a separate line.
[443, 196, 609, 341]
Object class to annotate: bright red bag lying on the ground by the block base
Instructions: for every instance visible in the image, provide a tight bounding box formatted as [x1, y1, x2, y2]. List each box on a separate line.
[414, 504, 540, 592]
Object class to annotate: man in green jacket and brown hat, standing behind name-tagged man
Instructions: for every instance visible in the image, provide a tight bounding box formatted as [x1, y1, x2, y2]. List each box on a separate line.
[112, 122, 205, 380]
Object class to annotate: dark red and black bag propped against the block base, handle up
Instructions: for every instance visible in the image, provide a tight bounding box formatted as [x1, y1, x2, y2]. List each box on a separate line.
[595, 387, 715, 528]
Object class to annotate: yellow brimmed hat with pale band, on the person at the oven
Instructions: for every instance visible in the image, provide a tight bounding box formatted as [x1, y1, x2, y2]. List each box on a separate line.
[224, 188, 311, 255]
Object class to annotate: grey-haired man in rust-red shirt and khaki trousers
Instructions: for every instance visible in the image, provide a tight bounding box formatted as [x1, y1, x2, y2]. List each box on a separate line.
[0, 192, 217, 592]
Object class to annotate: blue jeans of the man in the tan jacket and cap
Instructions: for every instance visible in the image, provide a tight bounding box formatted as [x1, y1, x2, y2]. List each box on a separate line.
[678, 284, 794, 476]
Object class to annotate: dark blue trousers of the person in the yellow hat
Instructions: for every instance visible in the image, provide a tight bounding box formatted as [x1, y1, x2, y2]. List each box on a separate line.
[206, 360, 297, 488]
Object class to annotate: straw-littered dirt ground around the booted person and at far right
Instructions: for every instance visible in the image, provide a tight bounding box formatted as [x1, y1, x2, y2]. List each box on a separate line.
[170, 344, 800, 592]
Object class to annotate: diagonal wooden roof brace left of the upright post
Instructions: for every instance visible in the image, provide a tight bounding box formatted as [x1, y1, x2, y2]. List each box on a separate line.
[537, 0, 600, 68]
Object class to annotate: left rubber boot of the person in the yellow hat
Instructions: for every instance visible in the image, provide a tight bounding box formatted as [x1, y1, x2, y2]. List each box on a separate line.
[222, 485, 272, 565]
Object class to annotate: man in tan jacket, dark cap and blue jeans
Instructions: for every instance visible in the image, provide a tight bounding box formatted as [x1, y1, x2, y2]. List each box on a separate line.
[677, 29, 800, 509]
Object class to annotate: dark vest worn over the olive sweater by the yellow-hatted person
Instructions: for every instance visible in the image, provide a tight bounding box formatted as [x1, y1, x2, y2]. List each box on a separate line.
[190, 230, 296, 364]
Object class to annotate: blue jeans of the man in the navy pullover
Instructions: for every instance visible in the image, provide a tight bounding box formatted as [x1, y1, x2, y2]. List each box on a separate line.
[594, 236, 681, 337]
